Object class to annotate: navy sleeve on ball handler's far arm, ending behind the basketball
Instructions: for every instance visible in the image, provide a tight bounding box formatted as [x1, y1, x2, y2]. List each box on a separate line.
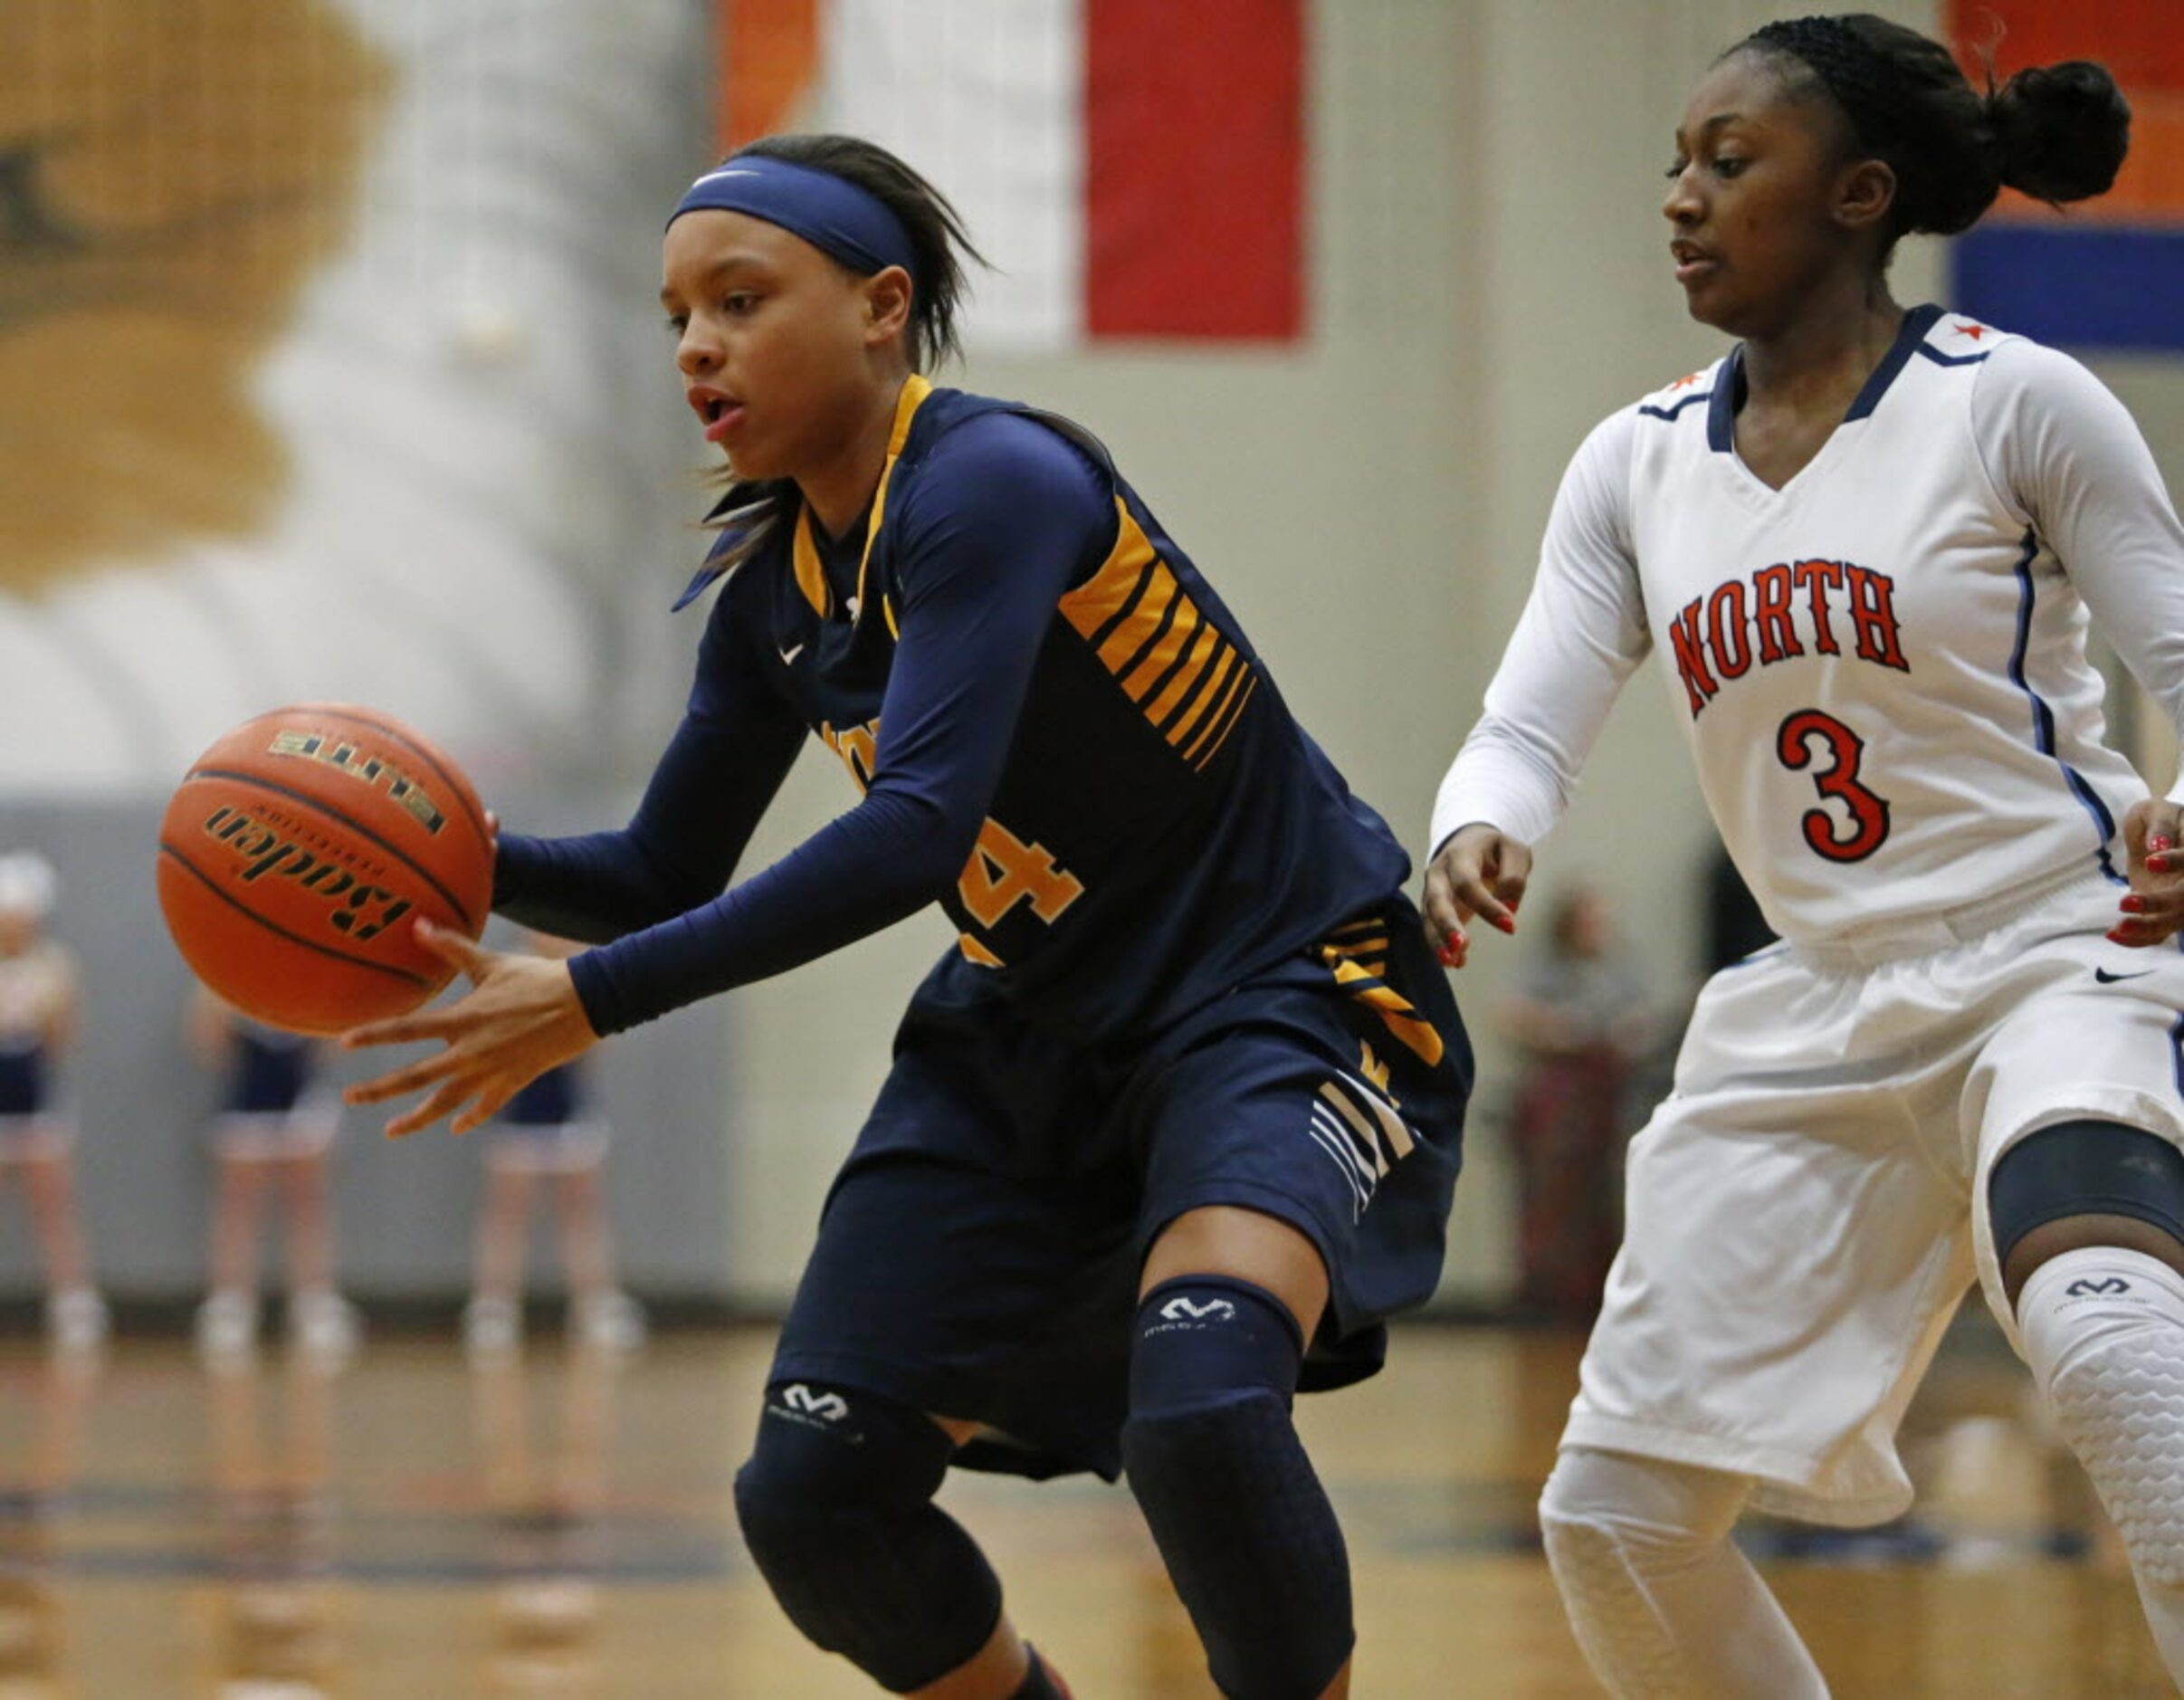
[493, 577, 806, 944]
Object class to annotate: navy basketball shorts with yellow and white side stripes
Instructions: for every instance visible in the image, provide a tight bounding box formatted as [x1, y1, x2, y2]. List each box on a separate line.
[773, 896, 1472, 1479]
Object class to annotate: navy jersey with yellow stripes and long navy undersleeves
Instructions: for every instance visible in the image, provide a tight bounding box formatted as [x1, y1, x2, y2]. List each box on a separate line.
[496, 378, 1439, 1060]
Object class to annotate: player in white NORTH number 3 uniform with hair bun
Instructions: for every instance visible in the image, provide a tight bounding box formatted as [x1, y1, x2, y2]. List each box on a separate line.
[1428, 15, 2184, 1700]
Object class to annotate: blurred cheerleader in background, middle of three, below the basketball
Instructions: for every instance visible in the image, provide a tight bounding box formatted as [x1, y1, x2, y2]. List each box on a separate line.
[188, 988, 358, 1363]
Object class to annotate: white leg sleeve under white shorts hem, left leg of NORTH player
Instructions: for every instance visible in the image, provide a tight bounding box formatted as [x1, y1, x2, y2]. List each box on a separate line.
[1540, 1447, 1828, 1700]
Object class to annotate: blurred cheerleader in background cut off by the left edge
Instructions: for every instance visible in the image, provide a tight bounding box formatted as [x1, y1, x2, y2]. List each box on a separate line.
[0, 850, 107, 1351]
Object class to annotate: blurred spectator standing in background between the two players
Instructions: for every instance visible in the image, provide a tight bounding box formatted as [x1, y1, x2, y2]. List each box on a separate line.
[1498, 887, 1660, 1322]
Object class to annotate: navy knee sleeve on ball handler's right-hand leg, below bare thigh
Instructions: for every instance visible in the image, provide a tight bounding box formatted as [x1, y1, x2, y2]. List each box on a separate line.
[1122, 1276, 1356, 1700]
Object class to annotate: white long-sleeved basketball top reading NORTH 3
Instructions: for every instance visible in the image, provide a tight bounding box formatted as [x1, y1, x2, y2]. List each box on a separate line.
[1433, 308, 2184, 941]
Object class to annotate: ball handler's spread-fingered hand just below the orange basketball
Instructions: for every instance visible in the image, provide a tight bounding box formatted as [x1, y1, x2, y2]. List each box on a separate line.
[340, 920, 598, 1139]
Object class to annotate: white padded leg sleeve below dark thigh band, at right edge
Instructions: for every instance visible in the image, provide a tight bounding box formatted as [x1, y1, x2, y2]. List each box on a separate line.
[2018, 1247, 2184, 1685]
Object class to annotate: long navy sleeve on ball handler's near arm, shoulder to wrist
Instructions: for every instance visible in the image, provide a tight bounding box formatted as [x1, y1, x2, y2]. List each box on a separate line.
[570, 415, 1116, 1034]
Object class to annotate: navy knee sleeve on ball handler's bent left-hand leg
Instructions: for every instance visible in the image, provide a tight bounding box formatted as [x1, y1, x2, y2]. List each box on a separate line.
[736, 1381, 1000, 1694]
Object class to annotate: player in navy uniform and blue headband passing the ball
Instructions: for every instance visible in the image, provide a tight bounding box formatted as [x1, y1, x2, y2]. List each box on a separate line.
[349, 138, 1470, 1700]
